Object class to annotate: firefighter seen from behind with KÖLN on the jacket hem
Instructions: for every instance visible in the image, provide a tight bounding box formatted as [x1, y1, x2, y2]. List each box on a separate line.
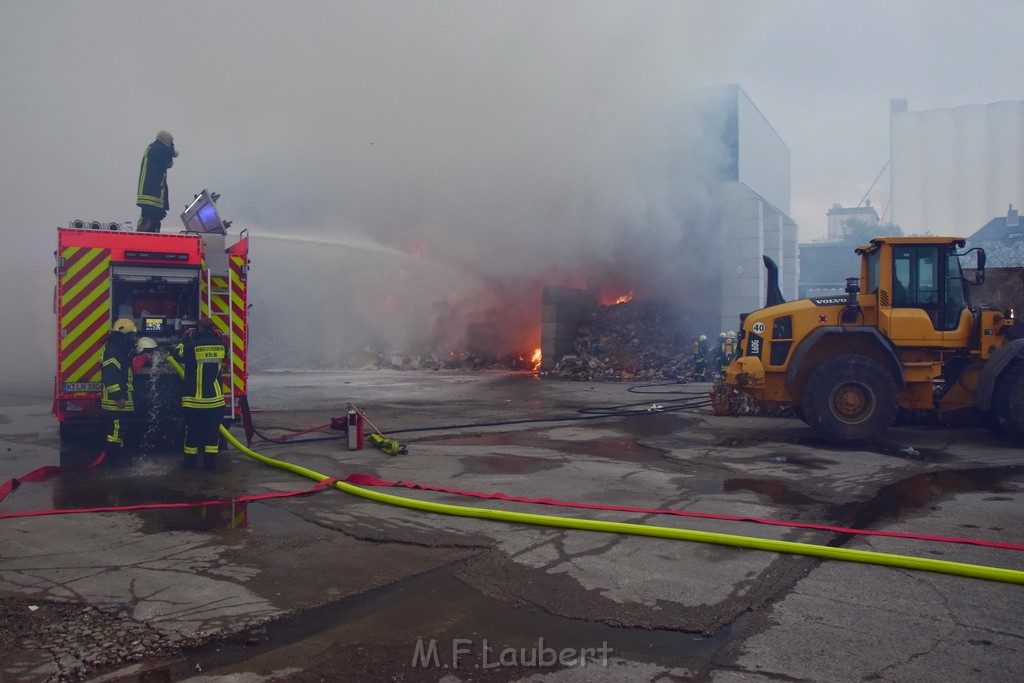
[174, 317, 227, 470]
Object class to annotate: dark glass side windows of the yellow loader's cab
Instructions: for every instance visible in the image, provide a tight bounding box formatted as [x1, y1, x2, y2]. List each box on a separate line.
[893, 245, 965, 330]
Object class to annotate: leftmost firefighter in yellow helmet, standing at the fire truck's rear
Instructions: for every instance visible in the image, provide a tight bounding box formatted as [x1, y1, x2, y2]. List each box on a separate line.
[99, 317, 138, 466]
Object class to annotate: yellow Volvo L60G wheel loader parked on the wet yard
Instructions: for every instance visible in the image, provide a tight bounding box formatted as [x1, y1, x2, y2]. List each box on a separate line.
[725, 237, 1024, 443]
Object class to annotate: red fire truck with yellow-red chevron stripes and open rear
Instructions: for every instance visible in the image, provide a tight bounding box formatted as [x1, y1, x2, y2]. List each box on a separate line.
[53, 189, 249, 440]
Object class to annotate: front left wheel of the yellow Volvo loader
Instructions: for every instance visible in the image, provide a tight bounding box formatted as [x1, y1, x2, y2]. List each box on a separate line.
[801, 354, 899, 444]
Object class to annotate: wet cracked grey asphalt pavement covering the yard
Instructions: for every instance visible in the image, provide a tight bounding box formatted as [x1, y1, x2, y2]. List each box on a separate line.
[0, 372, 1024, 683]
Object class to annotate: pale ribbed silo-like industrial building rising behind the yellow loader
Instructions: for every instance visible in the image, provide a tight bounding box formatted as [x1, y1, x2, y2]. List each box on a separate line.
[890, 99, 1024, 237]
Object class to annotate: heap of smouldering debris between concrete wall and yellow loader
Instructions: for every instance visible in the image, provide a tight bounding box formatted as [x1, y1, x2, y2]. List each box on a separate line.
[545, 300, 694, 381]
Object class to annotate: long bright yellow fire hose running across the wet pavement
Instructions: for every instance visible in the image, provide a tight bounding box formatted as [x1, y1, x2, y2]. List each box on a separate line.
[169, 357, 1024, 584]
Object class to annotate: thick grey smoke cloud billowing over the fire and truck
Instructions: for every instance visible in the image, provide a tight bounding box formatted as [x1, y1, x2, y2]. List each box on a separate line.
[0, 2, 753, 385]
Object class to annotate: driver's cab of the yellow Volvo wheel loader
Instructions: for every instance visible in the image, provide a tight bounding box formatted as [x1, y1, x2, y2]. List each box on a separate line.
[858, 238, 980, 347]
